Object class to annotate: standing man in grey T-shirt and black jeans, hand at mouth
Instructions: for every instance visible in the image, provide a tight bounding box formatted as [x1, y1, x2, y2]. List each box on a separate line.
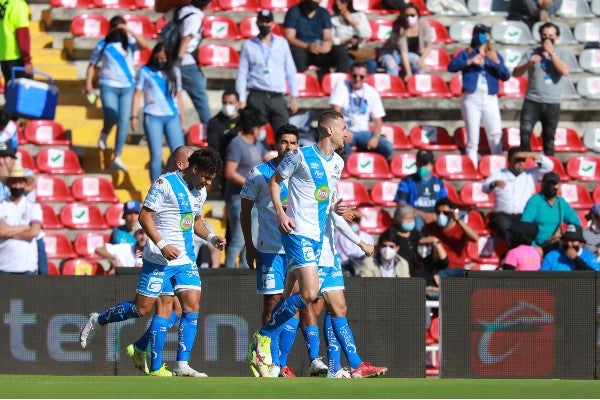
[513, 22, 569, 156]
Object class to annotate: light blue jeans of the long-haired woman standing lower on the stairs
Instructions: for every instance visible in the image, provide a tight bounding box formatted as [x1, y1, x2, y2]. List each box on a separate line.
[144, 114, 185, 182]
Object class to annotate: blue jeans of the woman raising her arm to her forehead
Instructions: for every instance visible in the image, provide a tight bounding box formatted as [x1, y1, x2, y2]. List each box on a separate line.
[100, 85, 134, 156]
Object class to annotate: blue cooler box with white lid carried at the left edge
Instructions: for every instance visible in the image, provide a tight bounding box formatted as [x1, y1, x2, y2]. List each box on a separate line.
[4, 67, 58, 119]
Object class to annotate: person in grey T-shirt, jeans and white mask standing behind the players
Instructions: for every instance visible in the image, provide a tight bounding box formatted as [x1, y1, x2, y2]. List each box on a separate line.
[224, 108, 267, 268]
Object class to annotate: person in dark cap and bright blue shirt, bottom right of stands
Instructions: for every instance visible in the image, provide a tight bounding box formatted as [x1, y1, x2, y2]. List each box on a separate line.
[540, 224, 600, 271]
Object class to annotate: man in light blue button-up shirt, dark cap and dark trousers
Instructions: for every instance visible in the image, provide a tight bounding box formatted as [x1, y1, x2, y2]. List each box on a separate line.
[235, 9, 299, 131]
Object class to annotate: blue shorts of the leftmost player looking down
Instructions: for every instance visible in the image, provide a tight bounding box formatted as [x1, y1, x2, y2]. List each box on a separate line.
[137, 260, 202, 297]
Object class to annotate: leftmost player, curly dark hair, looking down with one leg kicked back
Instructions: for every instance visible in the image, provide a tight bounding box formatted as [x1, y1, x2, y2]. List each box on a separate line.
[79, 149, 225, 377]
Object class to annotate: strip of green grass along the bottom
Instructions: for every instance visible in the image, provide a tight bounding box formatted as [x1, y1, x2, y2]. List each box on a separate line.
[0, 375, 600, 399]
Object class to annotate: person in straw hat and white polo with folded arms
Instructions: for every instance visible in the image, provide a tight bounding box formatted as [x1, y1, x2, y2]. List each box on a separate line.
[0, 164, 42, 275]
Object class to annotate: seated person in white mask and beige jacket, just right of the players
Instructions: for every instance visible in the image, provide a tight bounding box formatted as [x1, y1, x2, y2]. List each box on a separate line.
[359, 233, 410, 278]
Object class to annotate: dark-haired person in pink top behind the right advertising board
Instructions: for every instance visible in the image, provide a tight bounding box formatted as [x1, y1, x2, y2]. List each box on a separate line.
[502, 222, 542, 271]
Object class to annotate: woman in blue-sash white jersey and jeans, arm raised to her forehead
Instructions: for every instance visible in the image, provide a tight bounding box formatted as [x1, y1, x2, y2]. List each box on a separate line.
[85, 15, 148, 171]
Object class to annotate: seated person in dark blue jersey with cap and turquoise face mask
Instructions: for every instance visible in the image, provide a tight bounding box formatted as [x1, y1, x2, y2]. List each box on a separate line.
[394, 150, 448, 231]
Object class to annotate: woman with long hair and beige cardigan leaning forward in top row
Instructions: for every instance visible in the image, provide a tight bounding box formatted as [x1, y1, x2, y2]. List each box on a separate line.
[379, 3, 432, 81]
